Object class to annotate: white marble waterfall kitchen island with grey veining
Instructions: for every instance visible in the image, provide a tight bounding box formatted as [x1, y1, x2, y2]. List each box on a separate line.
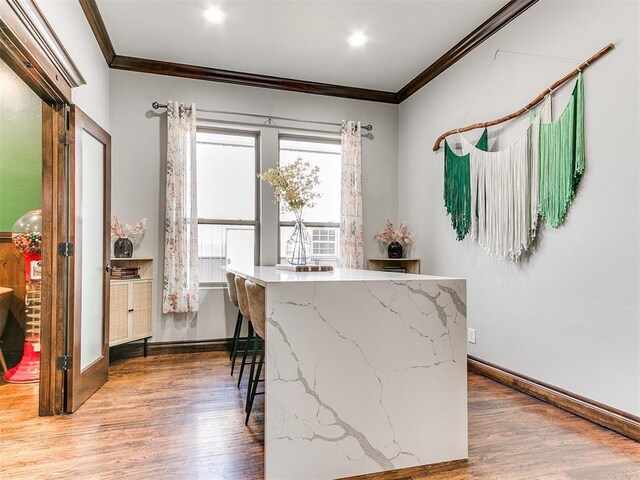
[230, 267, 468, 480]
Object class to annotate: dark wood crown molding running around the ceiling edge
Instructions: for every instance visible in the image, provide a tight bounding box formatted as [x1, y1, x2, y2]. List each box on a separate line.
[78, 0, 538, 104]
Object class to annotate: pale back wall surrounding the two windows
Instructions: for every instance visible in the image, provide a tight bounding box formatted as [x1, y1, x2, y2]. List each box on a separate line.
[110, 70, 398, 342]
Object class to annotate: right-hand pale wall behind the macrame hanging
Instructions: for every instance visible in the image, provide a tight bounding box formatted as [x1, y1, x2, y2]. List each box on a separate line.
[398, 1, 640, 415]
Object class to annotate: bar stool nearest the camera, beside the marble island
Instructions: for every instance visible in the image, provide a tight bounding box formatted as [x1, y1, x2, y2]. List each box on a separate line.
[244, 280, 266, 425]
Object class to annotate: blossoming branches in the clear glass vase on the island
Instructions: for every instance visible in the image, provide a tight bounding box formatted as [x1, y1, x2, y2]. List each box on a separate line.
[258, 158, 320, 211]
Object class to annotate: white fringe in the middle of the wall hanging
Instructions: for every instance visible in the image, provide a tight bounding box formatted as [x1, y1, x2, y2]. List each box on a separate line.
[462, 98, 551, 262]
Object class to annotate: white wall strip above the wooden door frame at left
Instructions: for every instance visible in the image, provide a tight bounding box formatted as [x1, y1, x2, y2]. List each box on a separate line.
[36, 0, 109, 131]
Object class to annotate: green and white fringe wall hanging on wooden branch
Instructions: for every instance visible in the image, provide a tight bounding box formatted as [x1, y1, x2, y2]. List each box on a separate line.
[433, 43, 614, 261]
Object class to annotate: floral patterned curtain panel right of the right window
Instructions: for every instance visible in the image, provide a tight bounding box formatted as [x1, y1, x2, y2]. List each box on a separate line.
[340, 120, 364, 268]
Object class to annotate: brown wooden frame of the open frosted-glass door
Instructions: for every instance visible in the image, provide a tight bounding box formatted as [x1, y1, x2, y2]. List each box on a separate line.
[65, 106, 111, 413]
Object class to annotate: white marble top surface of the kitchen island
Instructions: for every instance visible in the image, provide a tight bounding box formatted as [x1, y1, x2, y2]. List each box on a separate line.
[227, 267, 459, 286]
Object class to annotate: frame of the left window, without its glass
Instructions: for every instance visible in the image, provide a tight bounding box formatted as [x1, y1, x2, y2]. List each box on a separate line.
[196, 125, 261, 287]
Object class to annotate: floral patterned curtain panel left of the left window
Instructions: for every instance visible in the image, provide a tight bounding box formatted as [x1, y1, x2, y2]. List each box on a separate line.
[162, 101, 198, 313]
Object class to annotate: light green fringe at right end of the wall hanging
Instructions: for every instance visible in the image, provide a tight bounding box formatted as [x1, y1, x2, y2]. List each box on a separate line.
[538, 73, 584, 228]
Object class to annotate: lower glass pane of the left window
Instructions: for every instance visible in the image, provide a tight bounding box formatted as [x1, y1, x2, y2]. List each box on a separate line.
[198, 225, 255, 283]
